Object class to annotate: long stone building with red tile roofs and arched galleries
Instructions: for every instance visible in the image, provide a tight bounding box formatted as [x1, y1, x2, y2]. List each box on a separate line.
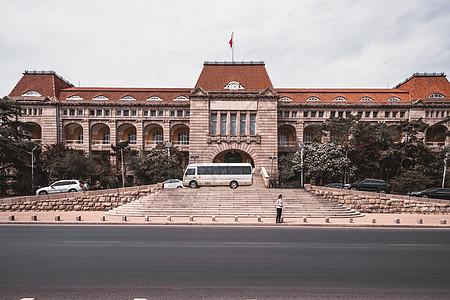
[8, 62, 450, 169]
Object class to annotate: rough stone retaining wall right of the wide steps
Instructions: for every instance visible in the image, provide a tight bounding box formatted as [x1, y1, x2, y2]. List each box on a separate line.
[305, 185, 450, 214]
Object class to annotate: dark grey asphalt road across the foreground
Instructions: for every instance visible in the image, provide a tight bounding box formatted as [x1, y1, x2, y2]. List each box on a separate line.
[0, 225, 450, 300]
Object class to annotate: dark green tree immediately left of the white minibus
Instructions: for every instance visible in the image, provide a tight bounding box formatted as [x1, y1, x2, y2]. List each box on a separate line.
[128, 144, 183, 184]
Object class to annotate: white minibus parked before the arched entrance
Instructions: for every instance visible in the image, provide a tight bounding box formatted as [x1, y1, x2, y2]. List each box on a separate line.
[183, 163, 253, 189]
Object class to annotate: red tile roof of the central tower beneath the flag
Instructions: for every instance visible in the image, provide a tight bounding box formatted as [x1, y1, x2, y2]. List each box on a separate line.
[195, 62, 273, 91]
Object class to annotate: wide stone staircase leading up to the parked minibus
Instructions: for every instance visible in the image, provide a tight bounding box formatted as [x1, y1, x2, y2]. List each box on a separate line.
[107, 176, 363, 218]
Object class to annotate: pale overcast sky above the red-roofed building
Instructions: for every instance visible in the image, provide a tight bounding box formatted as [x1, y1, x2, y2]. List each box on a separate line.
[0, 0, 450, 97]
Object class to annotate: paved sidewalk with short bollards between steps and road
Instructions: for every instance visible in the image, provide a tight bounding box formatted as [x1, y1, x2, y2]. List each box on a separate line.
[0, 211, 450, 228]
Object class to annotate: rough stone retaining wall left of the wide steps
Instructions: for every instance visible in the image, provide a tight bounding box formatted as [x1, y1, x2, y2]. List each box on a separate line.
[0, 185, 160, 211]
